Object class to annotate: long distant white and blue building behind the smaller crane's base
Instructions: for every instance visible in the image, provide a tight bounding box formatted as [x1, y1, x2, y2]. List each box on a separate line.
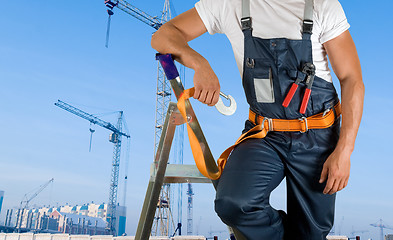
[15, 203, 126, 236]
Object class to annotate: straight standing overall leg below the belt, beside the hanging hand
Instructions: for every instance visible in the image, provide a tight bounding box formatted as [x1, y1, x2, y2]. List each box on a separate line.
[285, 124, 338, 240]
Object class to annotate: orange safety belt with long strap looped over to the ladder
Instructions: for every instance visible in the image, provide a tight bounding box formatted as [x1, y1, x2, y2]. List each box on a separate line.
[177, 88, 341, 180]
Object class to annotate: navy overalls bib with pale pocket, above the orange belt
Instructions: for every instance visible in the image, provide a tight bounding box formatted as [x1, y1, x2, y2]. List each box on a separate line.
[243, 0, 338, 119]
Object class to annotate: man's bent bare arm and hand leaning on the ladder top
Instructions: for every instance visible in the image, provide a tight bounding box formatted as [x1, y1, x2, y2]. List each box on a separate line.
[151, 8, 220, 106]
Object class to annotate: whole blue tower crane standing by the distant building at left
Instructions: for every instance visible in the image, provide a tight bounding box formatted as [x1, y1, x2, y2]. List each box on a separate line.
[55, 100, 130, 235]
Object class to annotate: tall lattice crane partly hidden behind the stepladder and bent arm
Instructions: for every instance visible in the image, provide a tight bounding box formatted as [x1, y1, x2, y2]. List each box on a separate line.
[105, 0, 185, 236]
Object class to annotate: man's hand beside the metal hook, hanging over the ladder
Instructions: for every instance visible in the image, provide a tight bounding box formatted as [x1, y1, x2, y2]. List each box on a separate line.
[194, 61, 220, 106]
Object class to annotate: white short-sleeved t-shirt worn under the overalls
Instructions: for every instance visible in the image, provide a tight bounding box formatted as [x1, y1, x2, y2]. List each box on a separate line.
[195, 0, 349, 82]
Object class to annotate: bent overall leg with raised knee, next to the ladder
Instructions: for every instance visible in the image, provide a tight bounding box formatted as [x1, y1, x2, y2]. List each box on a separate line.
[215, 139, 284, 240]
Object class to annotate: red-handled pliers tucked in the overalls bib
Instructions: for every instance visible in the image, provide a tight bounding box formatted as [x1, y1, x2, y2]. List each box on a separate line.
[282, 63, 315, 114]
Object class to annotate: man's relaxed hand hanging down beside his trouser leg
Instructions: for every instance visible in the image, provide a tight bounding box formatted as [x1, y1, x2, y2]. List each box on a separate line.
[319, 148, 351, 194]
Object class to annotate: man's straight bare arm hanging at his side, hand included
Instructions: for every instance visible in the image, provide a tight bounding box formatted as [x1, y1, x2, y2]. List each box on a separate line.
[320, 31, 364, 194]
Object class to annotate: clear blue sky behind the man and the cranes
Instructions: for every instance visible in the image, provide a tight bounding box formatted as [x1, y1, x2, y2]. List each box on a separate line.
[0, 0, 393, 239]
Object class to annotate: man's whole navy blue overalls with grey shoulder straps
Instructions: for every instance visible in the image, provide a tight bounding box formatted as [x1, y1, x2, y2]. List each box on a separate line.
[215, 0, 340, 240]
